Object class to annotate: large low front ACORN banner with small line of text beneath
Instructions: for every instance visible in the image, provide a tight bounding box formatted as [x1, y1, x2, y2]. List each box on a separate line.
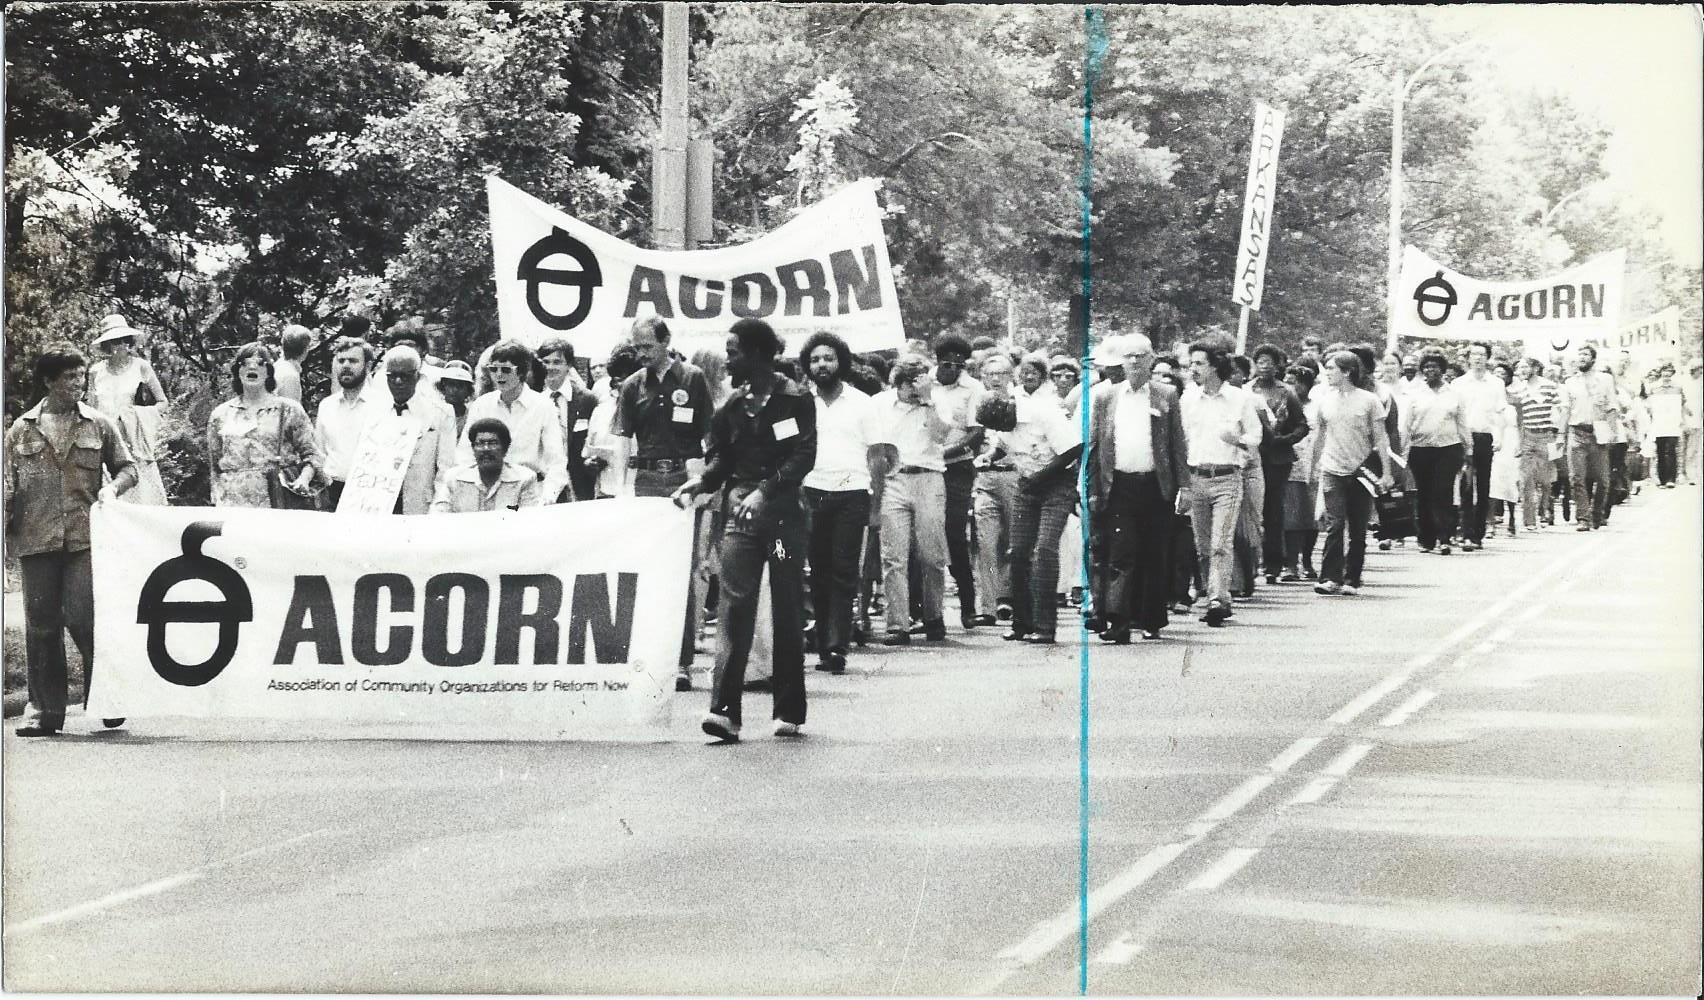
[89, 499, 692, 738]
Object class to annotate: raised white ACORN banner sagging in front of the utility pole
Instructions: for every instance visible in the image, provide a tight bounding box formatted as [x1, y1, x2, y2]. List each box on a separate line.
[487, 177, 905, 358]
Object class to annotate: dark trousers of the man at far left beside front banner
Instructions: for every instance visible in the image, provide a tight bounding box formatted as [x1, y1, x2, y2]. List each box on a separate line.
[17, 549, 95, 729]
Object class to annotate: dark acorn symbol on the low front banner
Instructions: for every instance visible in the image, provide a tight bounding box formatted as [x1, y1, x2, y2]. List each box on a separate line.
[136, 521, 254, 688]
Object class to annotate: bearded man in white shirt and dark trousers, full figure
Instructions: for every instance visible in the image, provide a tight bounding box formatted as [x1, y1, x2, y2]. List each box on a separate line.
[797, 332, 872, 673]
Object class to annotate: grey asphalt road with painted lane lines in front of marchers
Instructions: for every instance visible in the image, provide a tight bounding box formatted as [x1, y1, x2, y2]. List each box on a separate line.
[3, 489, 1704, 995]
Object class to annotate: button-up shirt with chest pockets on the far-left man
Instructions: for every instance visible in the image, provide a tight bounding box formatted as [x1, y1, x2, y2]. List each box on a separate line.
[5, 404, 131, 555]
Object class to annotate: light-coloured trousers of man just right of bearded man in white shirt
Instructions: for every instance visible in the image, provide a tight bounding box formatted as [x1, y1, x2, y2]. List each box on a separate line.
[881, 472, 947, 632]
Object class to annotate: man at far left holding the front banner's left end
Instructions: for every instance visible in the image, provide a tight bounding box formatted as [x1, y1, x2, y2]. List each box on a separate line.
[5, 344, 136, 736]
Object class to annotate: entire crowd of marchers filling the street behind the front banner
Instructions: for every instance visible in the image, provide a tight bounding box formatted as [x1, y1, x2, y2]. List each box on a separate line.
[5, 315, 1704, 741]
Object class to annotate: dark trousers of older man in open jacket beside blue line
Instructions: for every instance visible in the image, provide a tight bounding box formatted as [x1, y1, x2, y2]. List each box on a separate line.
[1106, 472, 1174, 630]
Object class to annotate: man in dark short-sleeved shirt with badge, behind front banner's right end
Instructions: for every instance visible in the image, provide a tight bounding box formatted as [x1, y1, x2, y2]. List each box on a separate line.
[613, 315, 712, 692]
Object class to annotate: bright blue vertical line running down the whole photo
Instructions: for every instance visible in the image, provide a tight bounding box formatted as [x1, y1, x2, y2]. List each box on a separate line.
[1077, 7, 1106, 995]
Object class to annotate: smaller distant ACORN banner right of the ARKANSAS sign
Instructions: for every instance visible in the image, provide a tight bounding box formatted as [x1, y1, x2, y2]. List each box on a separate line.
[1390, 247, 1627, 351]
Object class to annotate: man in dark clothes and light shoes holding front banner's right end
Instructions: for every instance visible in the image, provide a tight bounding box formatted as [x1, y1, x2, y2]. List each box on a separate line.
[675, 319, 816, 743]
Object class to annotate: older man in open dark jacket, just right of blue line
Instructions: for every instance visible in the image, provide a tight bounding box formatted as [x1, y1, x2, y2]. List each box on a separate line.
[1085, 334, 1189, 644]
